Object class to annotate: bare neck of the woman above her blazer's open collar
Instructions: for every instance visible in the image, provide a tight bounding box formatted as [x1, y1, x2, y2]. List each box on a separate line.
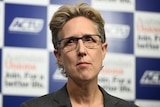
[67, 77, 103, 105]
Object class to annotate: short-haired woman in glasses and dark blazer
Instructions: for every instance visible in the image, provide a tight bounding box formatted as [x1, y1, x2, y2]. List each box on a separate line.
[21, 3, 137, 107]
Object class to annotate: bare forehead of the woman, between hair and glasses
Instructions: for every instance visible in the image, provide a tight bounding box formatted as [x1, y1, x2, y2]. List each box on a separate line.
[61, 16, 98, 38]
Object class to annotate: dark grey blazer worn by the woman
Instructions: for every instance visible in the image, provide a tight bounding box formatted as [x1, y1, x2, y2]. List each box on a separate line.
[21, 85, 138, 107]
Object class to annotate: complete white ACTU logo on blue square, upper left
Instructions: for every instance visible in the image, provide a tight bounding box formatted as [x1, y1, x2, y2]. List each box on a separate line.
[8, 17, 44, 33]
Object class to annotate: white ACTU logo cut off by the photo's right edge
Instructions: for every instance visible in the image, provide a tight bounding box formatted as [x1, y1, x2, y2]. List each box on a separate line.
[140, 70, 160, 85]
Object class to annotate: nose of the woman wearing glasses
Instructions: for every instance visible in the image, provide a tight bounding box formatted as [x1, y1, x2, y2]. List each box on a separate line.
[76, 39, 86, 56]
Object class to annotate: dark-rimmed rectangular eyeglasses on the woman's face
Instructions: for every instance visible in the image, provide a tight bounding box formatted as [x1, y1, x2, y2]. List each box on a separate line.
[58, 34, 101, 52]
